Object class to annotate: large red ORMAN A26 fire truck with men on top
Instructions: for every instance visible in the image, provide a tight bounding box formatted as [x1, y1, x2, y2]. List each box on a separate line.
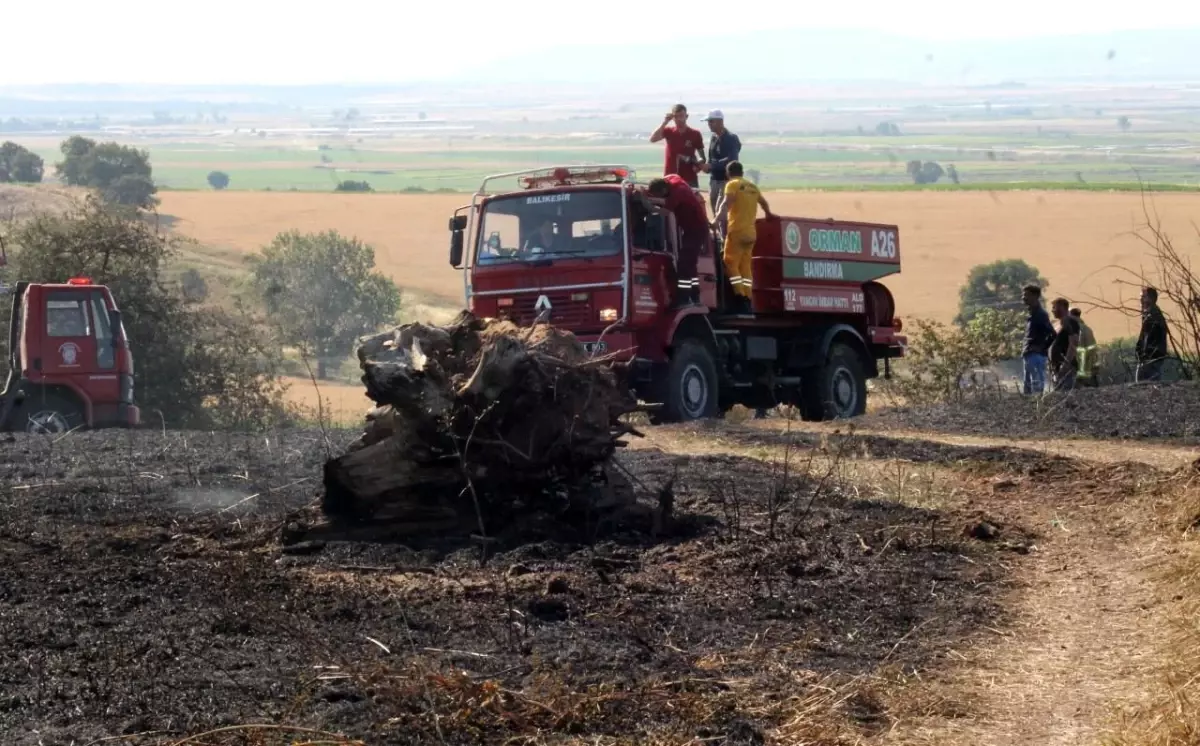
[450, 166, 907, 422]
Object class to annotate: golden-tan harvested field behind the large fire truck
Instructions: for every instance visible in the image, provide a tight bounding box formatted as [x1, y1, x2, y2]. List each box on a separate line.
[160, 191, 1200, 341]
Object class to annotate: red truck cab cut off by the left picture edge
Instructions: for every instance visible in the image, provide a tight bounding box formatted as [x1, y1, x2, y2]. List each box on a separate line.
[0, 277, 139, 433]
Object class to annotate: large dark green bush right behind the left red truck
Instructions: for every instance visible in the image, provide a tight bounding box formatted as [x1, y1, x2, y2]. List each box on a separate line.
[0, 195, 284, 427]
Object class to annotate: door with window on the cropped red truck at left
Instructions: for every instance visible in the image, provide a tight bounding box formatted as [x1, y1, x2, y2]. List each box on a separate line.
[39, 289, 96, 391]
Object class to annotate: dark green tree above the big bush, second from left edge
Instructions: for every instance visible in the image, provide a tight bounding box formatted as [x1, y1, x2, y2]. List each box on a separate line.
[55, 134, 158, 209]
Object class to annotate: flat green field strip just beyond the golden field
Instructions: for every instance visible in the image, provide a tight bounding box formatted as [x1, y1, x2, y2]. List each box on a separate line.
[18, 137, 1200, 192]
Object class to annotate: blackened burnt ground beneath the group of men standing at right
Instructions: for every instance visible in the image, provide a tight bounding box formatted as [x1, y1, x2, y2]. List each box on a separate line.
[860, 381, 1200, 445]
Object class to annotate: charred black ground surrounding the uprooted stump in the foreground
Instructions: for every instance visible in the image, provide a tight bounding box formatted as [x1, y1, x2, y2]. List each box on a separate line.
[0, 432, 1020, 746]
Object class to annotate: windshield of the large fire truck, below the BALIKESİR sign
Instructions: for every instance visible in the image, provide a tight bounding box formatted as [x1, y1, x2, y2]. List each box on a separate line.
[475, 189, 625, 266]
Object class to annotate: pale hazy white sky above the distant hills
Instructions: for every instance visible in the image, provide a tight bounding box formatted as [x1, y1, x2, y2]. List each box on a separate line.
[9, 0, 1200, 85]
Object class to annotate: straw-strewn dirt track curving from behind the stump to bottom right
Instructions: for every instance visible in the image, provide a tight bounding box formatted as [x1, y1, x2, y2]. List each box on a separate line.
[638, 420, 1180, 746]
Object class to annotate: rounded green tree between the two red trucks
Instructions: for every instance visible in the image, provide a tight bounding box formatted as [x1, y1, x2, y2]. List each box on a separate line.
[251, 230, 400, 378]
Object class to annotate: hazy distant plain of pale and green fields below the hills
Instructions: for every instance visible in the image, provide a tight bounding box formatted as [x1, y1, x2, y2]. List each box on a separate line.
[14, 85, 1200, 192]
